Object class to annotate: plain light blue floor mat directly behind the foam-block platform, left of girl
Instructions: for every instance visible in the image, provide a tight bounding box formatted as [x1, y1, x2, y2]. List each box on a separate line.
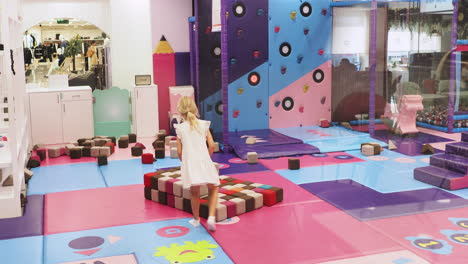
[100, 158, 180, 187]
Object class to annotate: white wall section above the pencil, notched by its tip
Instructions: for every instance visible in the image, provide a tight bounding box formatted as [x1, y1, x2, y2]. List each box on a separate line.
[151, 0, 192, 52]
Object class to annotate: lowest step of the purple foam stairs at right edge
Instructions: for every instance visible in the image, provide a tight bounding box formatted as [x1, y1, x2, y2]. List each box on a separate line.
[414, 166, 468, 190]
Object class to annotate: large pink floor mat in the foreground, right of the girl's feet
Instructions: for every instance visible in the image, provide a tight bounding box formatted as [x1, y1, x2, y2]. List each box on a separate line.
[212, 202, 402, 264]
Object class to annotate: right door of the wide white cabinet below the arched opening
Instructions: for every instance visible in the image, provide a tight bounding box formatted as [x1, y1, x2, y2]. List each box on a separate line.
[61, 100, 94, 142]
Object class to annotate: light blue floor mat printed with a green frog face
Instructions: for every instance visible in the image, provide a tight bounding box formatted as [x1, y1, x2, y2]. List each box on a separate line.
[44, 219, 233, 264]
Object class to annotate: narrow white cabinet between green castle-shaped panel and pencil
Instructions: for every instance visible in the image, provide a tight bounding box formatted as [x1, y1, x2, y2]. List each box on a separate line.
[132, 85, 159, 137]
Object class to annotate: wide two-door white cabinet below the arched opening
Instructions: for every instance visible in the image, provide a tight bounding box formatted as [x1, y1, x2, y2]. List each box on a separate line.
[28, 86, 94, 144]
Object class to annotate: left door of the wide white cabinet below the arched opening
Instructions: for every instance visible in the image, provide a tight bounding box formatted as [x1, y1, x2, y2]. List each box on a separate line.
[29, 93, 63, 144]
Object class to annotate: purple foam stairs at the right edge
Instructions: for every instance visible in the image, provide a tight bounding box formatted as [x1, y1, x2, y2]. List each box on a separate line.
[414, 132, 468, 190]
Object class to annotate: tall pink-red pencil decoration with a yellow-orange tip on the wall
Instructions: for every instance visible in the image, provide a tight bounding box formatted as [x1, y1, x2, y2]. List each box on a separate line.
[153, 36, 176, 131]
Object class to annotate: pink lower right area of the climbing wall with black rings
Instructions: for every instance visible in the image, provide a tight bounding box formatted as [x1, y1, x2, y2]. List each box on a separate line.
[269, 61, 332, 128]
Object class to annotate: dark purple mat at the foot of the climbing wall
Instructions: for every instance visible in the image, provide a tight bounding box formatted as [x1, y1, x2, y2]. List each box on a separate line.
[229, 129, 320, 159]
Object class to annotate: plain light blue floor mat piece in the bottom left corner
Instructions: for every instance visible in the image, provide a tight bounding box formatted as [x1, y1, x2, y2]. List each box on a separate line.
[0, 236, 43, 264]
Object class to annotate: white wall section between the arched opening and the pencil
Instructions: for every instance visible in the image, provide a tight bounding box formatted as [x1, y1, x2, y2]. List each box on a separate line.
[110, 0, 152, 89]
